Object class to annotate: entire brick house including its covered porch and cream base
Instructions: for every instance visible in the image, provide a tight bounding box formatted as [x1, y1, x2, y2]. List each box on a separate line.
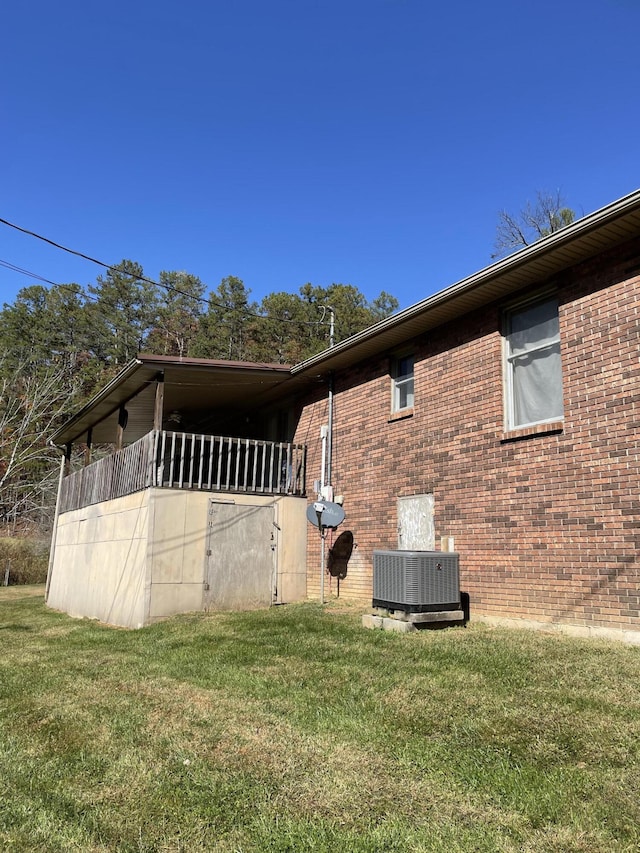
[47, 190, 640, 643]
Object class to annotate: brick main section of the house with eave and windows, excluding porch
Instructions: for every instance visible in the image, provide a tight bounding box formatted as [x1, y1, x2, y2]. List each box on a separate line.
[292, 192, 640, 642]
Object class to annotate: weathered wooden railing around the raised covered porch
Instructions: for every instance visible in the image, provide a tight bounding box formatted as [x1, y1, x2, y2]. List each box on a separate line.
[59, 430, 306, 512]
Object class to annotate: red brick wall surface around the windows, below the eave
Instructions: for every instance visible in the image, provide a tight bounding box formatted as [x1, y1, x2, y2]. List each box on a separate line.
[296, 236, 640, 629]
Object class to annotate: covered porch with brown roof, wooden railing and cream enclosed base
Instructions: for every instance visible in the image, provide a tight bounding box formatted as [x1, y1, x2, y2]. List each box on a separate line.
[47, 356, 306, 627]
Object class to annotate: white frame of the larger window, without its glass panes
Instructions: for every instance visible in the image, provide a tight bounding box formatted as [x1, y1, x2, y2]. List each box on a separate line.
[503, 291, 564, 431]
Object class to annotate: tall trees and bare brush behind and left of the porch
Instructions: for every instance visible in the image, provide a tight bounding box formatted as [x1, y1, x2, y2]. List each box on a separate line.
[0, 260, 398, 530]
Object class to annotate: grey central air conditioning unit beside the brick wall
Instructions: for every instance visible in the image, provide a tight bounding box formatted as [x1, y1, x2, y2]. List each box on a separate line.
[373, 551, 460, 613]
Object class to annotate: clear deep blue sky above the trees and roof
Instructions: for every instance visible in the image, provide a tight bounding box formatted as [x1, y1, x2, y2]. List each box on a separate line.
[0, 0, 640, 314]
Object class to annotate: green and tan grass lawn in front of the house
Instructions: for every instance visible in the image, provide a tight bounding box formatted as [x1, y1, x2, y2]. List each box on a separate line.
[0, 587, 640, 853]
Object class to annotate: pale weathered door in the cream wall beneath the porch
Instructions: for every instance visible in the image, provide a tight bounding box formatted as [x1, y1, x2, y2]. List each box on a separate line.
[204, 501, 277, 610]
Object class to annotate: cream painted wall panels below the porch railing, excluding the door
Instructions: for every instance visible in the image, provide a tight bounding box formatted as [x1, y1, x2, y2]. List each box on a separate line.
[47, 489, 307, 628]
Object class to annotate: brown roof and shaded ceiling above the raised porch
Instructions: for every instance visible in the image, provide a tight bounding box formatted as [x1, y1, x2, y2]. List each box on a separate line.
[51, 355, 308, 446]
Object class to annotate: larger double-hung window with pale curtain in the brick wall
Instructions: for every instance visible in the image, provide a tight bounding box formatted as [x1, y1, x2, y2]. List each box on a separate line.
[505, 297, 564, 429]
